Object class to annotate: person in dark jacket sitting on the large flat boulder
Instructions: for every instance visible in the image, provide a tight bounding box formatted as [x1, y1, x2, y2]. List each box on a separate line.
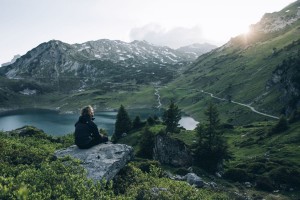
[75, 106, 108, 149]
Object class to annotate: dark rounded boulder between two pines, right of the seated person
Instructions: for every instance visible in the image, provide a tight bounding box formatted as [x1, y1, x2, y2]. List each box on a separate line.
[153, 135, 192, 167]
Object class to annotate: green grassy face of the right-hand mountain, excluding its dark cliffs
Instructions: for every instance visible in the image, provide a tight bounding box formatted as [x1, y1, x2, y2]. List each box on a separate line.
[161, 14, 300, 123]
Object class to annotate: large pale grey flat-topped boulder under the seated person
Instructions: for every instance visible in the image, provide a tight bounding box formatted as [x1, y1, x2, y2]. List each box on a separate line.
[55, 144, 133, 180]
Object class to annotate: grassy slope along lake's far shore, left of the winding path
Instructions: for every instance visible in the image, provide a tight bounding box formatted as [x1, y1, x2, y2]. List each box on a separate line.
[0, 77, 157, 111]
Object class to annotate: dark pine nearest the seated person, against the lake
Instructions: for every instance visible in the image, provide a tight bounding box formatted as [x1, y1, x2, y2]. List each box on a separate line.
[113, 105, 132, 140]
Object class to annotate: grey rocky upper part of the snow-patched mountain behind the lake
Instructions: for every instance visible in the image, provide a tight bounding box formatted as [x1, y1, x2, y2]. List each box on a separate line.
[0, 39, 209, 86]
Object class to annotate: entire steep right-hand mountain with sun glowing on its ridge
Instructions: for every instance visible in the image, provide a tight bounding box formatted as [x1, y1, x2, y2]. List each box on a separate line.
[161, 0, 300, 123]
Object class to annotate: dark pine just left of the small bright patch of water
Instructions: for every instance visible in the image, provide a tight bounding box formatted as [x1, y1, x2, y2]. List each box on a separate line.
[163, 101, 181, 132]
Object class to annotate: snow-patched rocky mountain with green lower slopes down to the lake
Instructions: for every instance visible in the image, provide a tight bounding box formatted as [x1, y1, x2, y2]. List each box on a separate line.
[0, 39, 213, 111]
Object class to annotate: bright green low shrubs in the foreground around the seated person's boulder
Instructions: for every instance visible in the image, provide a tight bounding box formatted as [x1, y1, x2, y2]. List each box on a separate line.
[0, 127, 229, 199]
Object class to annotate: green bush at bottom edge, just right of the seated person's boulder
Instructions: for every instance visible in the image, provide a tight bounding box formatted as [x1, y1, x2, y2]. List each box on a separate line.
[114, 163, 229, 200]
